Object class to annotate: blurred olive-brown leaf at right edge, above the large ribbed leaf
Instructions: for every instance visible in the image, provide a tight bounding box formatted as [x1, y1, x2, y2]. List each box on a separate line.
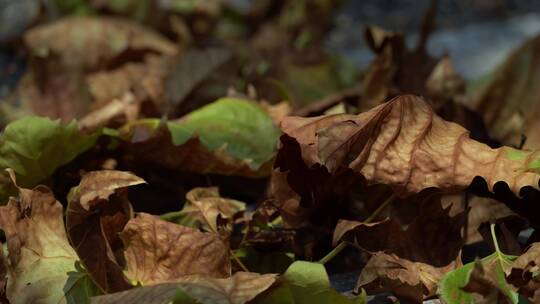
[469, 36, 540, 149]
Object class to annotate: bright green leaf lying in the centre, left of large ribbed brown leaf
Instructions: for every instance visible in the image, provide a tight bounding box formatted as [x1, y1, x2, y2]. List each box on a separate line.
[167, 98, 280, 170]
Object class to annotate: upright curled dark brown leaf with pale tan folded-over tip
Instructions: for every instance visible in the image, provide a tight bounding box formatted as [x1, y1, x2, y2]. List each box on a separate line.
[66, 170, 145, 292]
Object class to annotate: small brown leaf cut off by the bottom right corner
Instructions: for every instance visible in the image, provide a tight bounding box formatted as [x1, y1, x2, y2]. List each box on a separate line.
[507, 242, 540, 303]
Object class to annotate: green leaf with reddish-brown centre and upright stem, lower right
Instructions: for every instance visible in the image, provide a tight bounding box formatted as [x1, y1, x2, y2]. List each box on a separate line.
[437, 251, 518, 304]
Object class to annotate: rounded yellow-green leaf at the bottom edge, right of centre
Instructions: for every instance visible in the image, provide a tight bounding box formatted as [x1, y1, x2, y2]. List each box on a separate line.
[254, 261, 366, 304]
